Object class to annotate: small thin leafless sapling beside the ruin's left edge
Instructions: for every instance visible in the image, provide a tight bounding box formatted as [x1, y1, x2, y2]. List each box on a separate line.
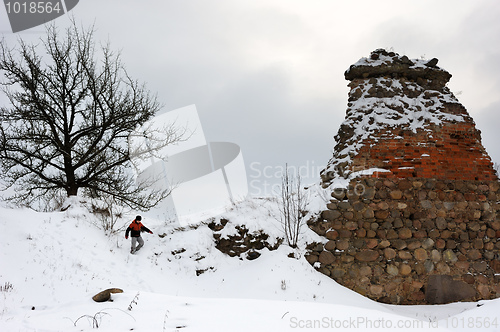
[278, 165, 307, 248]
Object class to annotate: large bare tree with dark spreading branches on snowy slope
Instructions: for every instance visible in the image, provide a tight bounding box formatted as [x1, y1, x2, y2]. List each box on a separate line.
[0, 21, 184, 210]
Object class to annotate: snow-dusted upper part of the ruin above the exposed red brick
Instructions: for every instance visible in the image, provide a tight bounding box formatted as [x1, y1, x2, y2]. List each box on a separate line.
[325, 49, 468, 184]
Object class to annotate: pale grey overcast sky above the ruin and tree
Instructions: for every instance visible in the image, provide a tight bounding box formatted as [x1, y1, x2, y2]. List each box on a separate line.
[0, 0, 500, 194]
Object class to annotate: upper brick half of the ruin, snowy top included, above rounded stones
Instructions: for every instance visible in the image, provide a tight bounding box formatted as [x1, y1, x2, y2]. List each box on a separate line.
[322, 49, 496, 186]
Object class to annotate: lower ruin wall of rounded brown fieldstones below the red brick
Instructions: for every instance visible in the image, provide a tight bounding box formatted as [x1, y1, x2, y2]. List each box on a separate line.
[307, 178, 500, 304]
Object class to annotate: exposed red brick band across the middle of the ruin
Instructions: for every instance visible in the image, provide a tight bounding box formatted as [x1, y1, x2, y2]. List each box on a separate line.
[351, 107, 497, 181]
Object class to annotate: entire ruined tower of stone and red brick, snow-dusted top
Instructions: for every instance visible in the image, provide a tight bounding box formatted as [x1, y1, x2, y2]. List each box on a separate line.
[307, 50, 500, 304]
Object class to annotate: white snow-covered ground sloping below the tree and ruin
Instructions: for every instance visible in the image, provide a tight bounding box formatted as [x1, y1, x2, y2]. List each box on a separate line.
[0, 198, 500, 332]
